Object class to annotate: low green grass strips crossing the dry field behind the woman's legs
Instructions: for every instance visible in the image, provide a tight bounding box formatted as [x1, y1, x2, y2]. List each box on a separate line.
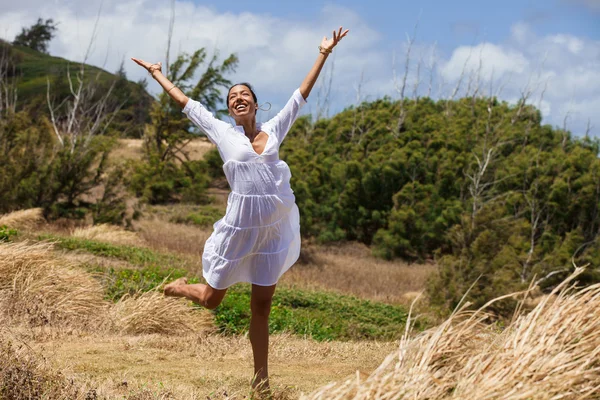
[40, 235, 412, 340]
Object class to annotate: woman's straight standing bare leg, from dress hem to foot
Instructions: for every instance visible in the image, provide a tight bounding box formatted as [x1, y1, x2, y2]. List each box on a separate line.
[250, 285, 275, 392]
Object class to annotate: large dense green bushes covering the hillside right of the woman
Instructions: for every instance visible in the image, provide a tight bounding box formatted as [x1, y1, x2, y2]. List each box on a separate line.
[282, 97, 600, 312]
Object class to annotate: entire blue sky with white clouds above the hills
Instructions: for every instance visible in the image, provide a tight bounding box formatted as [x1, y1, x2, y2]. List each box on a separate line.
[0, 0, 600, 136]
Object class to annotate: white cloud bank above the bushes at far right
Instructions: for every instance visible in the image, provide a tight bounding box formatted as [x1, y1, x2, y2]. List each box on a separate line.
[439, 22, 600, 136]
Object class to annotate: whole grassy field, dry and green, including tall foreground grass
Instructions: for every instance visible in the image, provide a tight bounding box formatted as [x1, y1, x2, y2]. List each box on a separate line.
[0, 158, 600, 400]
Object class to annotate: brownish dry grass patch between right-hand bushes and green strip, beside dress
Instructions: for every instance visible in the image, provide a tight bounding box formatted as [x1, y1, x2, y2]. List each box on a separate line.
[281, 243, 435, 304]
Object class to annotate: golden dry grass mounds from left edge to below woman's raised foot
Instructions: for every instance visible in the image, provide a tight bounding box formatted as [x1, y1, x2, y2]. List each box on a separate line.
[0, 241, 213, 334]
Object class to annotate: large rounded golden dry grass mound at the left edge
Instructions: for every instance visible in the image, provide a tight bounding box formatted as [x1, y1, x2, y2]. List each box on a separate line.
[0, 242, 107, 325]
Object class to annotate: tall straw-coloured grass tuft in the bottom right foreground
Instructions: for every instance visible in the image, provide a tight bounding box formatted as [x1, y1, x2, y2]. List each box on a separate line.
[304, 271, 600, 400]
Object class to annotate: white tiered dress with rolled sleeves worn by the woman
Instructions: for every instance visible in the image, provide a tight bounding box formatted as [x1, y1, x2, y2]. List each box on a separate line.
[183, 89, 306, 289]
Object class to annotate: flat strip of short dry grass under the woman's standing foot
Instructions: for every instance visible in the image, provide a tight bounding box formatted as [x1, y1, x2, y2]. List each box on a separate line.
[36, 335, 396, 399]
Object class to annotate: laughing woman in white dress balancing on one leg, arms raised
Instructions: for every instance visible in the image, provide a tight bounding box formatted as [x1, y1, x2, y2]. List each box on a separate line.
[132, 27, 348, 389]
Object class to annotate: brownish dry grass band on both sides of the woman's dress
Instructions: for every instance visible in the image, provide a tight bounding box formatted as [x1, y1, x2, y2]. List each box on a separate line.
[136, 209, 436, 305]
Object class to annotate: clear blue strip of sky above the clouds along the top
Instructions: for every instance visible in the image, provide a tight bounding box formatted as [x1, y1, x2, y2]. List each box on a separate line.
[207, 0, 600, 49]
